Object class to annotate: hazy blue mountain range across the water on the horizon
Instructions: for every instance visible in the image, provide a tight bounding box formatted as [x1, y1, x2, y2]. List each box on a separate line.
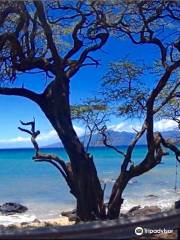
[46, 130, 180, 148]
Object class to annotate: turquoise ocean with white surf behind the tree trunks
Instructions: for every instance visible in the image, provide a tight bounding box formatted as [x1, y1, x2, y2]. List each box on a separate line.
[0, 146, 180, 224]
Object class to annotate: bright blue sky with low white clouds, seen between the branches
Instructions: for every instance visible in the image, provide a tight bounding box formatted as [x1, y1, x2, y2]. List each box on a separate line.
[0, 39, 178, 148]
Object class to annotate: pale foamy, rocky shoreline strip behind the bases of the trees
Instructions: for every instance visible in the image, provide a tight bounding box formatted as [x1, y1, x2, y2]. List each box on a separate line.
[0, 203, 174, 228]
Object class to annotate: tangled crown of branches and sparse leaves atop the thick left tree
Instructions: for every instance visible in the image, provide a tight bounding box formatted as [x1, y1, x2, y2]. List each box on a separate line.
[0, 1, 111, 83]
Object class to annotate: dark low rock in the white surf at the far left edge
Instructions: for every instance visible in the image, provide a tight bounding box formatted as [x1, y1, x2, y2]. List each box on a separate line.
[0, 202, 28, 215]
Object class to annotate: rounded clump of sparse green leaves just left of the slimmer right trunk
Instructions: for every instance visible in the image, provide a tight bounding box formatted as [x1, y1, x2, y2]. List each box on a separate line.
[102, 60, 149, 118]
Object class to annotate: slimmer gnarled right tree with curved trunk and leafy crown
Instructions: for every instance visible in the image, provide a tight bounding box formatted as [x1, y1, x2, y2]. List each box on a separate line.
[99, 1, 180, 218]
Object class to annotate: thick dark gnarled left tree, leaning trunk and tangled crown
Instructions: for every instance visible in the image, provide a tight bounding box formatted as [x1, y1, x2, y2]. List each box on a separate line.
[0, 1, 109, 220]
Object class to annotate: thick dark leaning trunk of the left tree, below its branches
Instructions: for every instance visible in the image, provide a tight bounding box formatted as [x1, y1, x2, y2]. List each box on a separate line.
[40, 78, 105, 221]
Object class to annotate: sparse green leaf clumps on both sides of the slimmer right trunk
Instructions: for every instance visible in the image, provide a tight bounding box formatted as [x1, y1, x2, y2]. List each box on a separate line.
[101, 60, 180, 122]
